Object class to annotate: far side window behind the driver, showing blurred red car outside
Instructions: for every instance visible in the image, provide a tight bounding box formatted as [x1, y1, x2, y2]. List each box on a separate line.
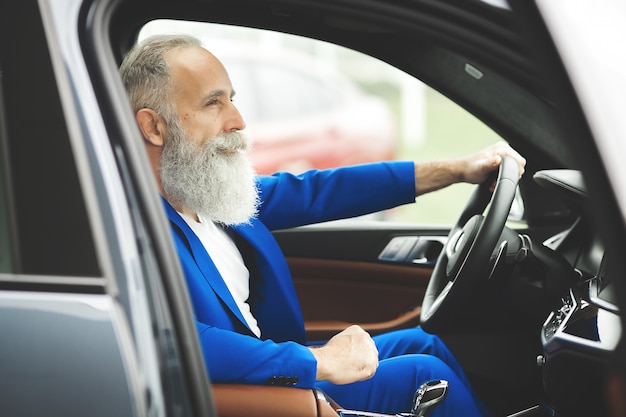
[140, 21, 508, 224]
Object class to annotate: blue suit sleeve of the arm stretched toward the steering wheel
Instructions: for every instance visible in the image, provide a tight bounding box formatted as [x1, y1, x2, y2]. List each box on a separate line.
[258, 162, 415, 230]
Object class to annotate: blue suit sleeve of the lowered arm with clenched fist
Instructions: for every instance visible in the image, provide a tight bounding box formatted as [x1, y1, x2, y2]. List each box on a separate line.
[196, 320, 317, 388]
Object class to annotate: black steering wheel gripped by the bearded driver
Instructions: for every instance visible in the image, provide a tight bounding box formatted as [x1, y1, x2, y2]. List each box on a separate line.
[421, 157, 519, 333]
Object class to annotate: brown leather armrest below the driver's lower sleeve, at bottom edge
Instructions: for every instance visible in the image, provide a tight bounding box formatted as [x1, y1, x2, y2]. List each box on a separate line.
[212, 384, 339, 417]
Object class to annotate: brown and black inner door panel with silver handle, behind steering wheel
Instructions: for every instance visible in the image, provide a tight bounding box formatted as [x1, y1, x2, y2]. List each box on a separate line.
[275, 222, 446, 341]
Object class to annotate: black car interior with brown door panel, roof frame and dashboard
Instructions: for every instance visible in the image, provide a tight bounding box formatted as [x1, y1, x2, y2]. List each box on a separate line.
[95, 1, 619, 415]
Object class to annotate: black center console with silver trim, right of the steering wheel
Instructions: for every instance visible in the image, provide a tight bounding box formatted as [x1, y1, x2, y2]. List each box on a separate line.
[537, 255, 621, 415]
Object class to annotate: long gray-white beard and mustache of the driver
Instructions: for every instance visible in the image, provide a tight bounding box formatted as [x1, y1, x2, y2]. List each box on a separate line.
[160, 120, 259, 226]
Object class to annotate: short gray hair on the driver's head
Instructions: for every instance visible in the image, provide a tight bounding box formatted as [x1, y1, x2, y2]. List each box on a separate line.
[120, 35, 201, 123]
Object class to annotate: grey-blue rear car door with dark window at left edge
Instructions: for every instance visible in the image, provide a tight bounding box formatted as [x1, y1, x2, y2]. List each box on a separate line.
[0, 2, 147, 416]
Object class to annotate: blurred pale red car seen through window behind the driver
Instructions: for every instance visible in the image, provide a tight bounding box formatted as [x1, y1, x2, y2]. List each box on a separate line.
[219, 51, 396, 174]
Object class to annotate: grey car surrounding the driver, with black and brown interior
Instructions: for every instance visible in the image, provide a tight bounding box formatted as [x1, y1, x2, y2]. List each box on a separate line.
[0, 0, 626, 417]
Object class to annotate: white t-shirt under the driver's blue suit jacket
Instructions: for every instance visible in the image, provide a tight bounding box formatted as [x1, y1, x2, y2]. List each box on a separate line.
[179, 213, 261, 337]
